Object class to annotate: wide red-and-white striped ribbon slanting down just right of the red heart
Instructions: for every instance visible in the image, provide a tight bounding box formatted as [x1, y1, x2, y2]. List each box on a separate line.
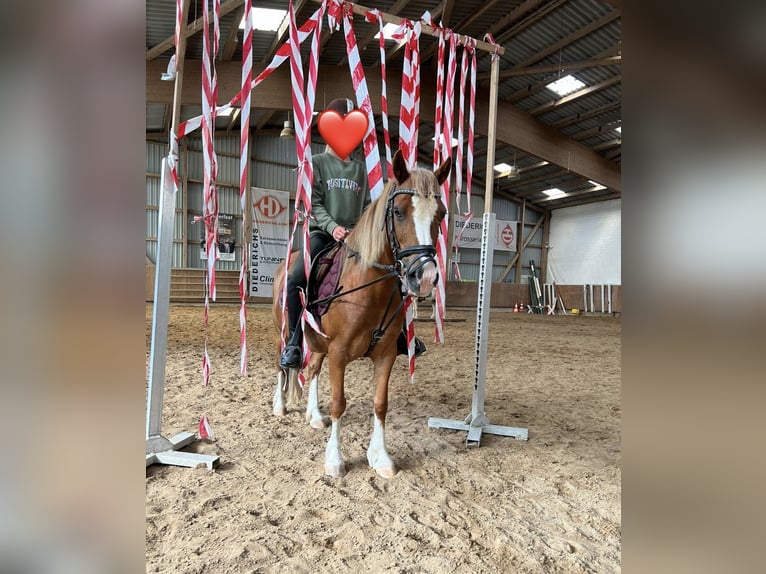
[342, 0, 383, 201]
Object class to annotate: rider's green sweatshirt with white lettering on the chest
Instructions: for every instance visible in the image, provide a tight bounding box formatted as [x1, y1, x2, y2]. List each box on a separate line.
[309, 152, 370, 235]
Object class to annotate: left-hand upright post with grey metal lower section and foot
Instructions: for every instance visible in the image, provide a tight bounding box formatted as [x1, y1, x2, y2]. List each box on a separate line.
[146, 0, 219, 470]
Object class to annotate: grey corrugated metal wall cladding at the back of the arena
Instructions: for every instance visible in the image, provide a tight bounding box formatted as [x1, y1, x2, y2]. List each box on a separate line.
[146, 135, 542, 282]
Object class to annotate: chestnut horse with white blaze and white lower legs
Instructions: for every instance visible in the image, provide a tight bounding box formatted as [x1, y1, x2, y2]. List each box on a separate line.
[273, 151, 452, 478]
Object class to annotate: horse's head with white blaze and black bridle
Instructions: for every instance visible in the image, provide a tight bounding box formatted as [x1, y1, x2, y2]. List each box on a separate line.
[386, 151, 452, 297]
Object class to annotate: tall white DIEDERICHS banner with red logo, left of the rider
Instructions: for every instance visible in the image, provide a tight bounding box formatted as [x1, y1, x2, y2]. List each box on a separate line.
[250, 187, 290, 297]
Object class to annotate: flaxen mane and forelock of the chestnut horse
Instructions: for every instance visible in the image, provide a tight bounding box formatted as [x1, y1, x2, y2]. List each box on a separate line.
[346, 167, 438, 267]
